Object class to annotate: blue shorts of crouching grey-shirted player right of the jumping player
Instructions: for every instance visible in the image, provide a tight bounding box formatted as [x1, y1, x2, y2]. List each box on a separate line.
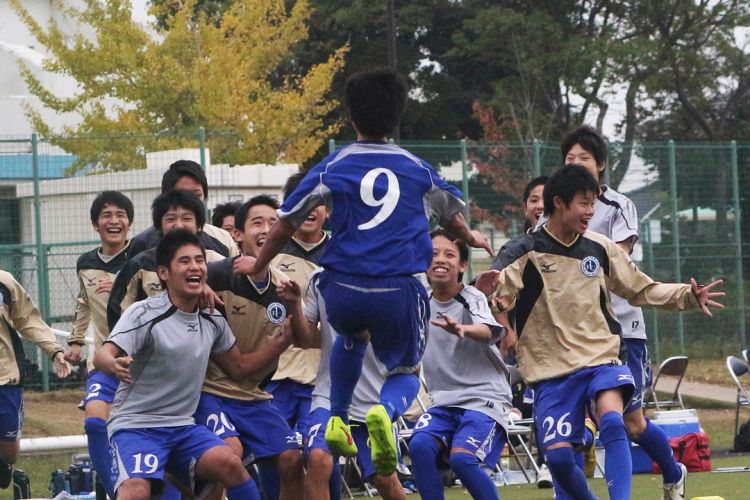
[414, 406, 507, 467]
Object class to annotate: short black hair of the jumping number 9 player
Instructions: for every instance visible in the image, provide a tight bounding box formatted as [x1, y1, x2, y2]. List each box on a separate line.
[344, 68, 407, 139]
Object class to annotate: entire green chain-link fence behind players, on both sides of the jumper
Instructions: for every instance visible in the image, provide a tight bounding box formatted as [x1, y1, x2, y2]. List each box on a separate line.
[0, 134, 750, 388]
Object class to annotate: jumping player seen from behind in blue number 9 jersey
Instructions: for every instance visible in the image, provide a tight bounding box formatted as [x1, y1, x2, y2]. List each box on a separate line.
[241, 69, 492, 476]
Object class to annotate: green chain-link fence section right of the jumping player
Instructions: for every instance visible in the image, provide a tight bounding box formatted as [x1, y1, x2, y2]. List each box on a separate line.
[330, 141, 750, 360]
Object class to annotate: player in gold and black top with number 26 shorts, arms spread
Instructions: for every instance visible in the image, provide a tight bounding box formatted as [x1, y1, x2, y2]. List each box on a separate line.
[490, 165, 724, 500]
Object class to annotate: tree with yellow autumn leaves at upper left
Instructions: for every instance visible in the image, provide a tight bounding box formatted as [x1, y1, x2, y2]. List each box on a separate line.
[11, 0, 347, 171]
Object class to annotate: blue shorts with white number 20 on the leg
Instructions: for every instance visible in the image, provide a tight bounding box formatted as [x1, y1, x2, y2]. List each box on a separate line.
[194, 392, 300, 464]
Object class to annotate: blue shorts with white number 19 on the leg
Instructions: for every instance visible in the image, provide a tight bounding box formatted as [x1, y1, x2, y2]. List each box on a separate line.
[110, 425, 226, 495]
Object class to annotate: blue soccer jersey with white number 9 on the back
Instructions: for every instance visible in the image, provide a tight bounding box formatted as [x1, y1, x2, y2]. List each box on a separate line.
[279, 142, 465, 277]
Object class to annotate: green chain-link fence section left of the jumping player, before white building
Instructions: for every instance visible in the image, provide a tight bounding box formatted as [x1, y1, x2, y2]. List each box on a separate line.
[0, 130, 299, 390]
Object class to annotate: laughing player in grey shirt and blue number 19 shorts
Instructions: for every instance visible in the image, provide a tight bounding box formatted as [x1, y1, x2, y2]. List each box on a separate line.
[94, 229, 270, 500]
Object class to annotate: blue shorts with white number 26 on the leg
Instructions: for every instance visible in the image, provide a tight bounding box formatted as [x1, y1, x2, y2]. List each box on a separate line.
[534, 365, 635, 449]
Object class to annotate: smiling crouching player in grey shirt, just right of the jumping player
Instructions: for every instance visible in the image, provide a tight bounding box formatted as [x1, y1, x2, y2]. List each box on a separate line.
[409, 230, 511, 500]
